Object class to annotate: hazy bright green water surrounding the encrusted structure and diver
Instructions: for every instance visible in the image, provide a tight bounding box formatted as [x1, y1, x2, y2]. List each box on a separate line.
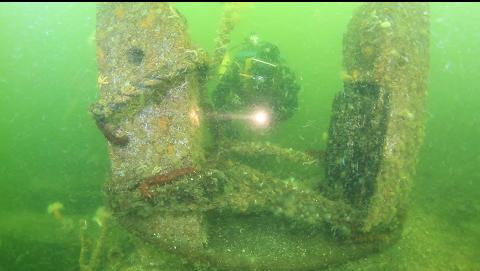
[0, 3, 480, 270]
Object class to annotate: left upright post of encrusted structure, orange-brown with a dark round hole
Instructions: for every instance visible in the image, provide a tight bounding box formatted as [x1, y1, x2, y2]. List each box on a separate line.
[92, 3, 202, 193]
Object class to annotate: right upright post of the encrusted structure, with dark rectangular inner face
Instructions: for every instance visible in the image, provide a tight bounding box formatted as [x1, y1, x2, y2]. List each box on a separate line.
[326, 3, 429, 231]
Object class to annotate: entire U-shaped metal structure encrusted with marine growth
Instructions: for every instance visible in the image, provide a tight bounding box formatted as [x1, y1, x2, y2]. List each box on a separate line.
[91, 3, 429, 270]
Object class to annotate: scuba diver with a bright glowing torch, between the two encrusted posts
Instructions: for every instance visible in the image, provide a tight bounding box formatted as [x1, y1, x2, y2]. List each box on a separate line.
[212, 34, 300, 139]
